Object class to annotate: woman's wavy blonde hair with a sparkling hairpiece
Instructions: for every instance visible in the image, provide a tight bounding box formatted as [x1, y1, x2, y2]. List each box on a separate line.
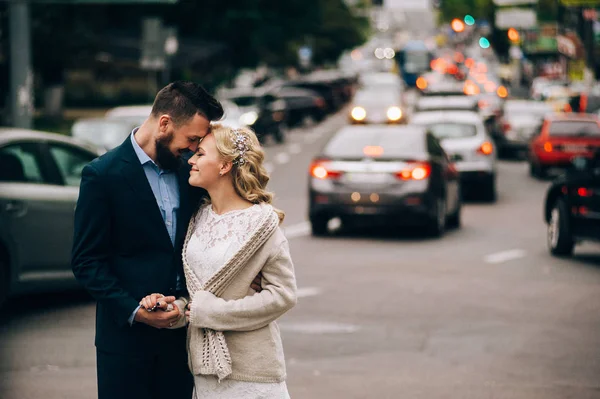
[209, 123, 285, 222]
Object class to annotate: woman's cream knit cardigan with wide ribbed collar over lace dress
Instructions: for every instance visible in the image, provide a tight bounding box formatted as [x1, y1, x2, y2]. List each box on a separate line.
[183, 204, 296, 382]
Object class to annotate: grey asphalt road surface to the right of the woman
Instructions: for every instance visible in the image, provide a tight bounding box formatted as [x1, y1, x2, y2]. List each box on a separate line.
[280, 163, 600, 399]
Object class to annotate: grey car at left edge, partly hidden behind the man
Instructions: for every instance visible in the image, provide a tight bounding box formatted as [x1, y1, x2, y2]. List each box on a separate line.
[0, 128, 104, 303]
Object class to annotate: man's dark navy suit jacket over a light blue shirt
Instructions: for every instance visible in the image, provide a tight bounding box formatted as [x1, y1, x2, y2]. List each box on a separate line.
[72, 136, 203, 354]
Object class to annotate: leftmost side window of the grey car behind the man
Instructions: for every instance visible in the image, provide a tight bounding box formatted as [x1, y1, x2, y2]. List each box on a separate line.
[0, 143, 44, 183]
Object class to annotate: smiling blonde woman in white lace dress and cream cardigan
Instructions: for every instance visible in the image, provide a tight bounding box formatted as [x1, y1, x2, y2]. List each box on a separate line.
[142, 125, 296, 399]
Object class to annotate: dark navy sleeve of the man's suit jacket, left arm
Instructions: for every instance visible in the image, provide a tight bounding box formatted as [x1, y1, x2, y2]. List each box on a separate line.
[71, 164, 139, 326]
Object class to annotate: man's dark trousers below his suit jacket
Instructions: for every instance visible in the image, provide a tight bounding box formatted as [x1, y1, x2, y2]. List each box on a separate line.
[96, 349, 194, 399]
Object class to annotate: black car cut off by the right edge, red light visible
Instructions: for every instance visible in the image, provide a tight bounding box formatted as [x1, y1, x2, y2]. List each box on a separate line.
[544, 150, 600, 256]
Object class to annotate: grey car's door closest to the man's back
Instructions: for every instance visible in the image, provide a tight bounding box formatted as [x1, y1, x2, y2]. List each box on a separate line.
[45, 141, 97, 272]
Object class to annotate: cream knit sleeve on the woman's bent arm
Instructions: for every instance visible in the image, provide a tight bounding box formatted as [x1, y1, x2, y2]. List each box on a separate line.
[190, 242, 297, 331]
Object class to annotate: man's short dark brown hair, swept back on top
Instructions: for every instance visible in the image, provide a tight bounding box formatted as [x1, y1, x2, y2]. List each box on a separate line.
[152, 80, 223, 125]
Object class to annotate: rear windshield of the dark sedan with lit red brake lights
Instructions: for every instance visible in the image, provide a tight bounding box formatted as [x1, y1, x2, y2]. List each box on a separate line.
[324, 129, 425, 159]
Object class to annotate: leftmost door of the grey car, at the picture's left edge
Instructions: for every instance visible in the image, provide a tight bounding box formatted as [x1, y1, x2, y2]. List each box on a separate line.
[0, 141, 65, 282]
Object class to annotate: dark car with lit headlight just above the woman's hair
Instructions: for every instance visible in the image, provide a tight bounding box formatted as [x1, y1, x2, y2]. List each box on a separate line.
[221, 89, 287, 143]
